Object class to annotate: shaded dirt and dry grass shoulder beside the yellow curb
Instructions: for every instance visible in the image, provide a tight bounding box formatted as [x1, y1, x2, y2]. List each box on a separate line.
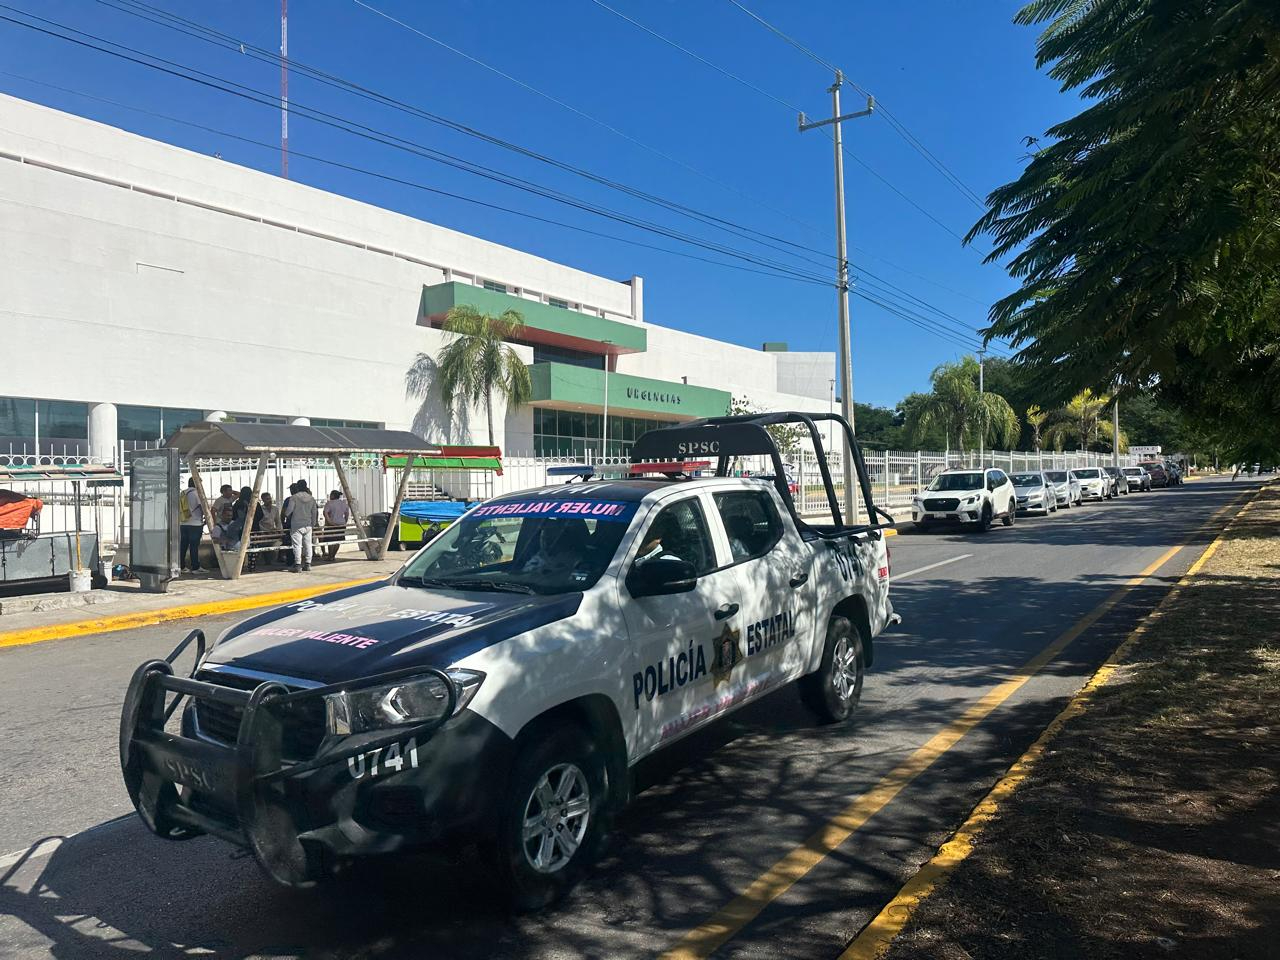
[887, 484, 1280, 960]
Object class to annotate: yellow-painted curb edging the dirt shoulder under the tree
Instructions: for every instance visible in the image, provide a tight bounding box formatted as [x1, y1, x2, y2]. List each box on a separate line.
[840, 488, 1254, 960]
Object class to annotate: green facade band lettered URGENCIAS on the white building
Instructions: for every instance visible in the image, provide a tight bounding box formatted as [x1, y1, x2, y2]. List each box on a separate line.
[529, 364, 730, 420]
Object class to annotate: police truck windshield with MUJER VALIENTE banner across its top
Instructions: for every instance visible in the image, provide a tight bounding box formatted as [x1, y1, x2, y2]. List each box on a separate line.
[398, 499, 636, 594]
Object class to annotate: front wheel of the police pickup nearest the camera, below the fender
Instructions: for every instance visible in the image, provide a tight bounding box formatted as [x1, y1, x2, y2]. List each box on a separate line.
[492, 722, 611, 913]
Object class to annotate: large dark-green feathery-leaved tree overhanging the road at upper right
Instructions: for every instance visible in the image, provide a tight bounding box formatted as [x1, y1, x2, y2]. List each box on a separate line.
[968, 0, 1280, 449]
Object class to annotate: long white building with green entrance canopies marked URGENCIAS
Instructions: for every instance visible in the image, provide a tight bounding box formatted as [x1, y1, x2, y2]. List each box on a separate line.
[0, 96, 835, 457]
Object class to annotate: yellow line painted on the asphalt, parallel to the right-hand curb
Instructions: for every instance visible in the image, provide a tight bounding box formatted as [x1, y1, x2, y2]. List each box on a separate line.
[662, 545, 1183, 960]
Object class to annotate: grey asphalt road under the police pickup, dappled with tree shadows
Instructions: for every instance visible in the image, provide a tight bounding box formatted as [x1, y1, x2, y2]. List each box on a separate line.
[0, 480, 1252, 960]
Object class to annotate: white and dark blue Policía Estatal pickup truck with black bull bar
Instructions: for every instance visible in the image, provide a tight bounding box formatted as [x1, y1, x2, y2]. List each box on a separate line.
[120, 413, 897, 909]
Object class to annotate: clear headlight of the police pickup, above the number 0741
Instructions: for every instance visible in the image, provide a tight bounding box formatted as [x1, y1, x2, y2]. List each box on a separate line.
[324, 668, 484, 736]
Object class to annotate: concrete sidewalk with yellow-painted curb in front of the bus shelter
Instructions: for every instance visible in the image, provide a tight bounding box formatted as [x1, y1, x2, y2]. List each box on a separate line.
[0, 552, 412, 648]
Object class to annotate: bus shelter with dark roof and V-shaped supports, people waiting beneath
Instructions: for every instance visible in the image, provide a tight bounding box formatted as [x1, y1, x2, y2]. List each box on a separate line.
[165, 422, 442, 580]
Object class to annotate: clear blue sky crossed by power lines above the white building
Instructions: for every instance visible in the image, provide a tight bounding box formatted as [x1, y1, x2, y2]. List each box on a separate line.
[0, 0, 1076, 406]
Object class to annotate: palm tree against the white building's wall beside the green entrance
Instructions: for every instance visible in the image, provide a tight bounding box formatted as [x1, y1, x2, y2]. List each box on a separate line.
[404, 305, 534, 445]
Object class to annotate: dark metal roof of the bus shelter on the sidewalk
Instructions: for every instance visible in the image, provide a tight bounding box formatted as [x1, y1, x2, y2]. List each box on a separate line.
[165, 421, 440, 457]
